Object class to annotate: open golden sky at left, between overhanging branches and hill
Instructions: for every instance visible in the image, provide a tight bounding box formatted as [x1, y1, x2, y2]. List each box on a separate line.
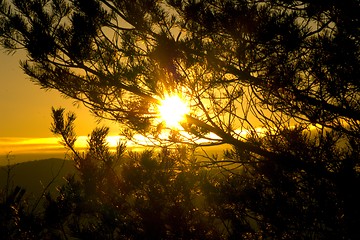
[0, 49, 118, 160]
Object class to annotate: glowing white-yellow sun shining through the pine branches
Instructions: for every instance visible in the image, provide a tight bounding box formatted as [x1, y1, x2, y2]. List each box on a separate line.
[159, 95, 190, 128]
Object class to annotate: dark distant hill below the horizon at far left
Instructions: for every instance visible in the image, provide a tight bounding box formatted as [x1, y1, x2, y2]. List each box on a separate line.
[0, 158, 75, 198]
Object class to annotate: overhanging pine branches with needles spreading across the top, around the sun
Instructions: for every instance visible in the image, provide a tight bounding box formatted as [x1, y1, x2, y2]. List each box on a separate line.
[1, 0, 360, 150]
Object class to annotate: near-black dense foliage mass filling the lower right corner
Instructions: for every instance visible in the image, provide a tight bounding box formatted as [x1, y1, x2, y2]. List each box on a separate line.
[205, 126, 360, 239]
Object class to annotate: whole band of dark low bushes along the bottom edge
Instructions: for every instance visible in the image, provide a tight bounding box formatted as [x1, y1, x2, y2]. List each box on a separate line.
[1, 109, 360, 239]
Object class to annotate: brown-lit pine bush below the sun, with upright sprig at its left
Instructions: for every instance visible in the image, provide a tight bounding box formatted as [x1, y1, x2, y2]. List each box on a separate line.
[43, 109, 225, 239]
